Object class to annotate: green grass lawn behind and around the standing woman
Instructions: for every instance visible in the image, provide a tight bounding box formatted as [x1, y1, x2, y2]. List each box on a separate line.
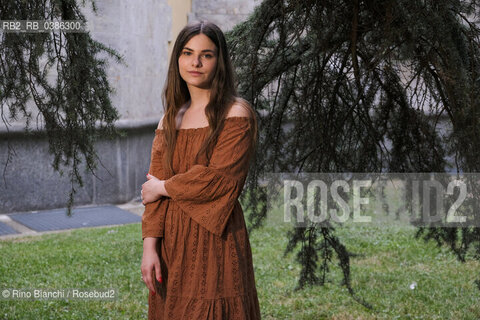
[0, 206, 480, 319]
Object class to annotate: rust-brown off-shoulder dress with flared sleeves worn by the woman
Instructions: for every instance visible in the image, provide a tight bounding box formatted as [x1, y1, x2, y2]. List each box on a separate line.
[142, 117, 260, 320]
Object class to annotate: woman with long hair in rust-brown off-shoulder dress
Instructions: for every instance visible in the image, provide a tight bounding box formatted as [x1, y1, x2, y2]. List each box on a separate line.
[141, 22, 260, 320]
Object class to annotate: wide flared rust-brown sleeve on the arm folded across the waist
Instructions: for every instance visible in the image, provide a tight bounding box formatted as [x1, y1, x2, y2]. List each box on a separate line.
[164, 117, 253, 236]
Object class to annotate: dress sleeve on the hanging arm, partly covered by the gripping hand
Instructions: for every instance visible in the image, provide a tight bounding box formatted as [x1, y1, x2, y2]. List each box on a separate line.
[142, 129, 170, 240]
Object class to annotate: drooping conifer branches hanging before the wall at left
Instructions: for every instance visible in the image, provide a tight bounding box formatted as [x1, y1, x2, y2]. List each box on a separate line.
[0, 0, 124, 215]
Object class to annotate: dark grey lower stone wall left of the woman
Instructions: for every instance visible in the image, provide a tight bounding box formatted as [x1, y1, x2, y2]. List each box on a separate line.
[0, 126, 153, 213]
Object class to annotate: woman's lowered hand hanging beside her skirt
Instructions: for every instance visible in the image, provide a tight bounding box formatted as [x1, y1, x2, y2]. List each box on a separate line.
[140, 238, 162, 294]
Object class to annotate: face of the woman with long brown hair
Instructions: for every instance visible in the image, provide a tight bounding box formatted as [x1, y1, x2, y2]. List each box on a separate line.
[178, 33, 217, 89]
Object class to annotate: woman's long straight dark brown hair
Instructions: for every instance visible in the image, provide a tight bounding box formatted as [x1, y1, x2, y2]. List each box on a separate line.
[162, 21, 257, 174]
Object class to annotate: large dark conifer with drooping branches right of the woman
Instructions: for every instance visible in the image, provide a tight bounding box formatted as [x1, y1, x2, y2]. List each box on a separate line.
[228, 0, 480, 304]
